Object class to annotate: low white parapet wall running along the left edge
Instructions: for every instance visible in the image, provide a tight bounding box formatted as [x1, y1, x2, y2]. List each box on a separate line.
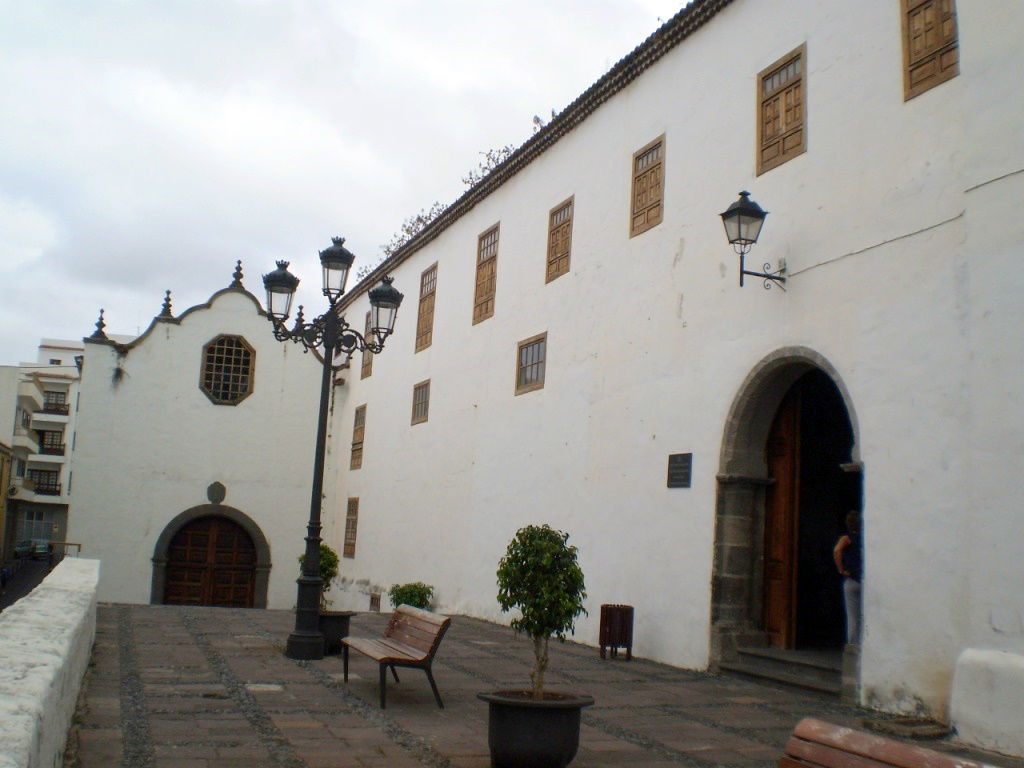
[0, 558, 99, 768]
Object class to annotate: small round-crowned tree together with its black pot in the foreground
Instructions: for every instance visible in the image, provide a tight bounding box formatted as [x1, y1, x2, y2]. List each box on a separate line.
[476, 525, 594, 768]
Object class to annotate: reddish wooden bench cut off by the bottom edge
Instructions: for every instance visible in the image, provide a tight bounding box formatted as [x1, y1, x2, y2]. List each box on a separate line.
[778, 718, 992, 768]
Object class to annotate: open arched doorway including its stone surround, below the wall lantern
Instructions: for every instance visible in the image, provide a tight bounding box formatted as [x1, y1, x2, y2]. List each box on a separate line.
[712, 347, 861, 663]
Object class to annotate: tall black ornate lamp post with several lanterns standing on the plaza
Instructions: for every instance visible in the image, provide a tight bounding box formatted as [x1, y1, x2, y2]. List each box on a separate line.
[263, 238, 402, 659]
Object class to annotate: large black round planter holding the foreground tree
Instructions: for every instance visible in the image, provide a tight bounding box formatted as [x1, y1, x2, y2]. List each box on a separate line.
[476, 691, 594, 768]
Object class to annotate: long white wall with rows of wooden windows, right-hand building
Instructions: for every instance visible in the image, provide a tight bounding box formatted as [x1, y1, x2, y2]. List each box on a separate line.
[330, 0, 1024, 729]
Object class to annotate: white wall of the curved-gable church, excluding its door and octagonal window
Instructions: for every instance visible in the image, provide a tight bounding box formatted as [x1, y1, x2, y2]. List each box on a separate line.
[69, 291, 321, 608]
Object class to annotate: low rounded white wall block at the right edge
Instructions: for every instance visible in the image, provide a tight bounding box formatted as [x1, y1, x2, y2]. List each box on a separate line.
[949, 648, 1024, 755]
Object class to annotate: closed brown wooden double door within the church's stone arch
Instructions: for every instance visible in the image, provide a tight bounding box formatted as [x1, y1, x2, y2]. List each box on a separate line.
[164, 515, 256, 608]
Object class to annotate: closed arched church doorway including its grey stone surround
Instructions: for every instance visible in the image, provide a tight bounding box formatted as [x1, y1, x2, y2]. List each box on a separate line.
[151, 504, 270, 608]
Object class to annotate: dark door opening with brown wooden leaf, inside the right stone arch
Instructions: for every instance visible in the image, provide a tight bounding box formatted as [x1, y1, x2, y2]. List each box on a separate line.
[763, 371, 860, 648]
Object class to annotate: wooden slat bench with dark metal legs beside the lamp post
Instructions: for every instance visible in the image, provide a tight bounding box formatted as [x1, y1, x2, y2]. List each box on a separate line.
[341, 605, 452, 710]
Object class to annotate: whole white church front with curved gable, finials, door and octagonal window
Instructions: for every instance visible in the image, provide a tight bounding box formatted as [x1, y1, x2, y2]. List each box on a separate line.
[69, 269, 319, 608]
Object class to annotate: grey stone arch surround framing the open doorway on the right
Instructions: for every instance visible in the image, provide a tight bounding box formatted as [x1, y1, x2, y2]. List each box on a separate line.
[711, 346, 862, 664]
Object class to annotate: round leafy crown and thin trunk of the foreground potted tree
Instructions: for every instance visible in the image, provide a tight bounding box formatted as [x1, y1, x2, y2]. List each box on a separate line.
[498, 525, 587, 698]
